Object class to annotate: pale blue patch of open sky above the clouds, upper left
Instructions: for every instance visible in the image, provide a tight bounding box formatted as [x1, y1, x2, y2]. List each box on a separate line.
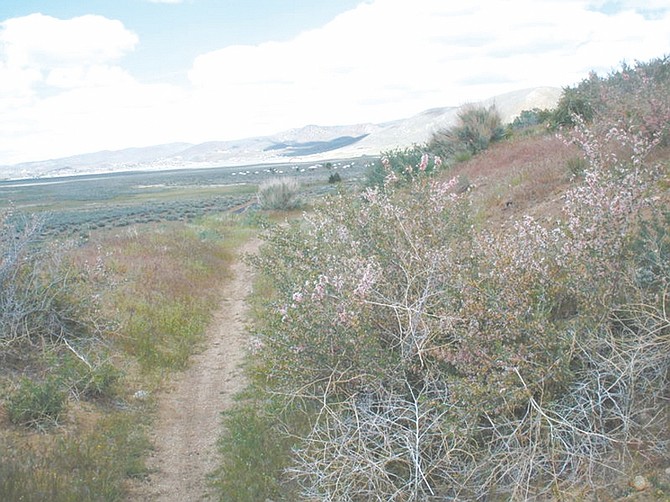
[0, 0, 368, 83]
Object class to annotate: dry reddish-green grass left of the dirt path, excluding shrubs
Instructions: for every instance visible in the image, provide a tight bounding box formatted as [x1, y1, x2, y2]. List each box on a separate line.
[0, 218, 251, 502]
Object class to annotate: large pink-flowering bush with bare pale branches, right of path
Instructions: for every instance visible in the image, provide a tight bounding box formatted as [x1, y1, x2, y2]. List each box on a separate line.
[249, 57, 670, 500]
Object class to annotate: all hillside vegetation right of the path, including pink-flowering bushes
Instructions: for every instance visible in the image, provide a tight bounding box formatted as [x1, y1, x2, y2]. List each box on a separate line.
[218, 58, 670, 501]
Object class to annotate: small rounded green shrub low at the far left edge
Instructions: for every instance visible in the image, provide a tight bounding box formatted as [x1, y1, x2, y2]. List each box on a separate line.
[5, 377, 67, 426]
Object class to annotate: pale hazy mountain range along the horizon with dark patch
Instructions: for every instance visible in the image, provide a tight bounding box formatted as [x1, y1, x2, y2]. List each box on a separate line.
[0, 87, 561, 180]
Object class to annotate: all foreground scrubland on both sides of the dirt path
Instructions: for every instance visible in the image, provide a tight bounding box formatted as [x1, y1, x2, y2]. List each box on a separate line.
[0, 58, 670, 501]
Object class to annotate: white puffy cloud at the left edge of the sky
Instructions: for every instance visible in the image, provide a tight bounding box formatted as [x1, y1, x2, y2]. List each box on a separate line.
[0, 14, 162, 162]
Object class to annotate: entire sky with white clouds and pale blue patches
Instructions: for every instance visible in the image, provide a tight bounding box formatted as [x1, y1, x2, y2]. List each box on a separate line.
[0, 0, 670, 165]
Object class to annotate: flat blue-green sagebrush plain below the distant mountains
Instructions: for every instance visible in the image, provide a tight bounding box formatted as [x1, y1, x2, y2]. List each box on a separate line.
[0, 159, 370, 237]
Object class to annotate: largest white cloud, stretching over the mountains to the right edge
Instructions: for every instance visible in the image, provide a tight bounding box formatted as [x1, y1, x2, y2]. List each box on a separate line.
[184, 0, 670, 137]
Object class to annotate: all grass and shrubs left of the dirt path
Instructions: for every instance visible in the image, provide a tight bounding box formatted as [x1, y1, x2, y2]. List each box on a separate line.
[0, 207, 258, 501]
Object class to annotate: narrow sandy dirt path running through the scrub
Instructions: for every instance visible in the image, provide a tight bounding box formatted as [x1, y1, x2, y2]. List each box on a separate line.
[129, 239, 260, 502]
